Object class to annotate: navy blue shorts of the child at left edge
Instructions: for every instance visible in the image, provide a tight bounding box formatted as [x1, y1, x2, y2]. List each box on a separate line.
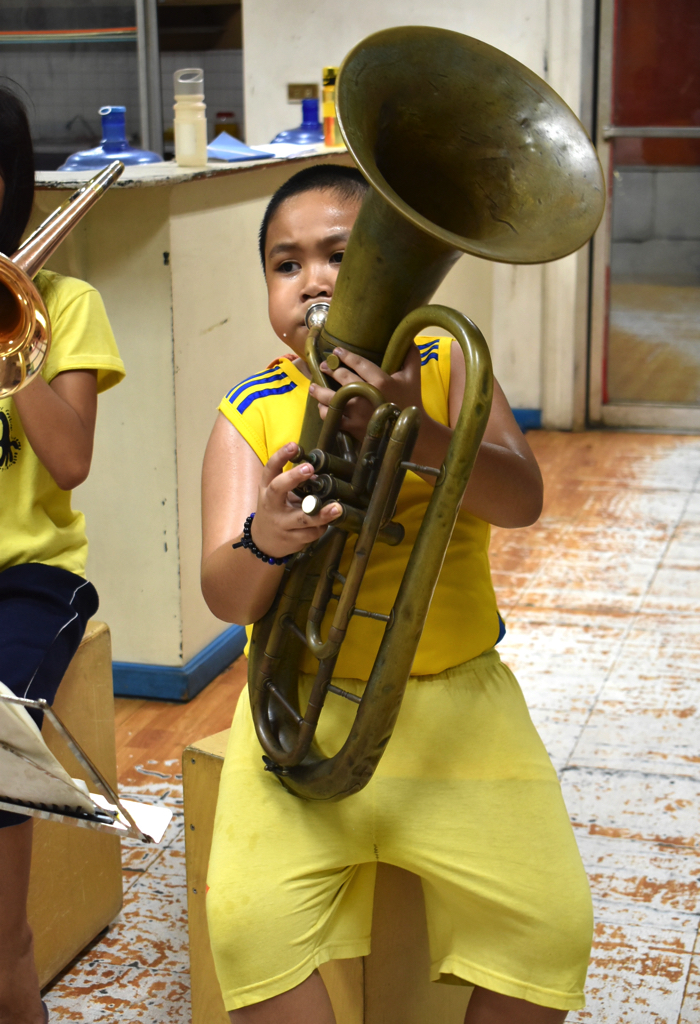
[0, 562, 99, 828]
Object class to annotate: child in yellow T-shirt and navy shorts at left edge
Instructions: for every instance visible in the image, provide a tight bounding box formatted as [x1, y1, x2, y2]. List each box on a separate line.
[0, 88, 124, 1024]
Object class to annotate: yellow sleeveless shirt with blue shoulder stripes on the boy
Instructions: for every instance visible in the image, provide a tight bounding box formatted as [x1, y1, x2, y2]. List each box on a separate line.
[219, 337, 505, 680]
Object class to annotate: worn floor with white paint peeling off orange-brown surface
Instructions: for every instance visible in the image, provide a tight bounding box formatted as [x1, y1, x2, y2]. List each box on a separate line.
[46, 432, 700, 1024]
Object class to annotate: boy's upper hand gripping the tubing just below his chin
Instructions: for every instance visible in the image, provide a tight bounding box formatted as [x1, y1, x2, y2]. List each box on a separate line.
[309, 345, 423, 441]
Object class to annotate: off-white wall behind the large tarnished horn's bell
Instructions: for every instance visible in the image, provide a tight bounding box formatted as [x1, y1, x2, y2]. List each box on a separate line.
[244, 0, 590, 428]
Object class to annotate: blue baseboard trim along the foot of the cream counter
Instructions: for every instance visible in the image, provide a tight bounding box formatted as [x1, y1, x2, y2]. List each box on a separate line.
[112, 626, 246, 700]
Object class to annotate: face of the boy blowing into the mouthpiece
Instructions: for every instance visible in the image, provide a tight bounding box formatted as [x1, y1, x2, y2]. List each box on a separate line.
[265, 190, 360, 356]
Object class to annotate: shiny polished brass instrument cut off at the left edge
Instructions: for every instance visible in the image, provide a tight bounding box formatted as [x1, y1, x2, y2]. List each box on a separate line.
[0, 160, 124, 398]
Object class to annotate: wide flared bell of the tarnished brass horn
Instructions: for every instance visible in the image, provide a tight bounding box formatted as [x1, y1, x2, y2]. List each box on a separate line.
[322, 27, 605, 362]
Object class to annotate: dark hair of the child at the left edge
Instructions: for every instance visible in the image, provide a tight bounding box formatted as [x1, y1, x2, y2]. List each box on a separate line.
[0, 85, 34, 256]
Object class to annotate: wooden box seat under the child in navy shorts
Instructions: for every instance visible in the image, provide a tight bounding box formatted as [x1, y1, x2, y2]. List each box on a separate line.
[29, 622, 122, 987]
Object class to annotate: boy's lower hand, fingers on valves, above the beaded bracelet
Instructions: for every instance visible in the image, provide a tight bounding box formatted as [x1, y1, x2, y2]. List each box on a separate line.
[251, 443, 341, 558]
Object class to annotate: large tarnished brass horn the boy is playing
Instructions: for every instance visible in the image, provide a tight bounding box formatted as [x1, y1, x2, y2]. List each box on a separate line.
[249, 28, 605, 800]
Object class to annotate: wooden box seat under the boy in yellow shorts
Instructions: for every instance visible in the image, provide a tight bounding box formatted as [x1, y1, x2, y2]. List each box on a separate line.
[182, 729, 471, 1024]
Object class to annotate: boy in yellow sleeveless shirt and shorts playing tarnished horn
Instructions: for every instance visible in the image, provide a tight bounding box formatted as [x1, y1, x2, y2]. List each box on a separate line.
[202, 166, 592, 1024]
